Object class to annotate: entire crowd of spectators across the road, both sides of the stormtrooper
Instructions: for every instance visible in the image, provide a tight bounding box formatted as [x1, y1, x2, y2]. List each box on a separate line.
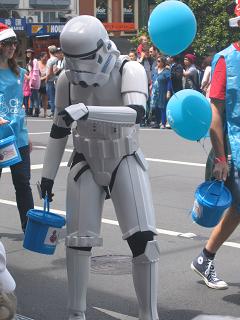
[23, 35, 212, 129]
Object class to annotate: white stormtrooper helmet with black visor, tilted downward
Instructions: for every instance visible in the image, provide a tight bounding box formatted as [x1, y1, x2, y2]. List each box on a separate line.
[60, 15, 120, 87]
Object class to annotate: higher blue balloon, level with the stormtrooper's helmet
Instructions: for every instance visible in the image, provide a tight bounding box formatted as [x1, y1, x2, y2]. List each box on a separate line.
[148, 0, 197, 56]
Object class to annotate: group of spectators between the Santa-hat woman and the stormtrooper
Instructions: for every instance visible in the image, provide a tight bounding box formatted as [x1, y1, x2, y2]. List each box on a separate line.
[23, 45, 64, 118]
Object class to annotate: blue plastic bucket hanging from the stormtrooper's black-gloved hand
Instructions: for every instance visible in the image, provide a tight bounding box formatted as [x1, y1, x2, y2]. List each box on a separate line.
[23, 199, 66, 255]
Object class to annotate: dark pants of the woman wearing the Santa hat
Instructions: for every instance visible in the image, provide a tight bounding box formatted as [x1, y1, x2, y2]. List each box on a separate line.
[0, 146, 34, 231]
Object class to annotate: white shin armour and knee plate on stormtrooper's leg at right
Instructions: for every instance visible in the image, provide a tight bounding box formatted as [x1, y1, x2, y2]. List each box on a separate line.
[132, 240, 159, 320]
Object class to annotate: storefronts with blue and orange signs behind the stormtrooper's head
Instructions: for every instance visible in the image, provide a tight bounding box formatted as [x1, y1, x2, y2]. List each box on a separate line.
[0, 0, 154, 65]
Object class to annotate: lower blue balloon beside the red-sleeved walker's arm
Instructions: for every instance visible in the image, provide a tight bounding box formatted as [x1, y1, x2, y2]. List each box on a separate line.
[167, 89, 212, 141]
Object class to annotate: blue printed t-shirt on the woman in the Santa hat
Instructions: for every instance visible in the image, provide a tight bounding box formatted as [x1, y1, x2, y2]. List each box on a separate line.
[0, 68, 29, 148]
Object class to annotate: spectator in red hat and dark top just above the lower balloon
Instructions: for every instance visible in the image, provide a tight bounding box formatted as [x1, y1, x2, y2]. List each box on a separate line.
[183, 53, 200, 91]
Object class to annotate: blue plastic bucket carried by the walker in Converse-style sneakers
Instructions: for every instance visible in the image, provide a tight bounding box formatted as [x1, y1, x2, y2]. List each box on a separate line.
[192, 180, 232, 228]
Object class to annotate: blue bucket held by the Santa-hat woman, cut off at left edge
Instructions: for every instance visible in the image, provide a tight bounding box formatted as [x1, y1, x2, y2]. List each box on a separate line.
[0, 124, 22, 168]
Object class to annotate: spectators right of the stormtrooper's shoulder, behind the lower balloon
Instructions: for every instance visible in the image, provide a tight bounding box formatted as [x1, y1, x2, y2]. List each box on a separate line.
[129, 35, 212, 129]
